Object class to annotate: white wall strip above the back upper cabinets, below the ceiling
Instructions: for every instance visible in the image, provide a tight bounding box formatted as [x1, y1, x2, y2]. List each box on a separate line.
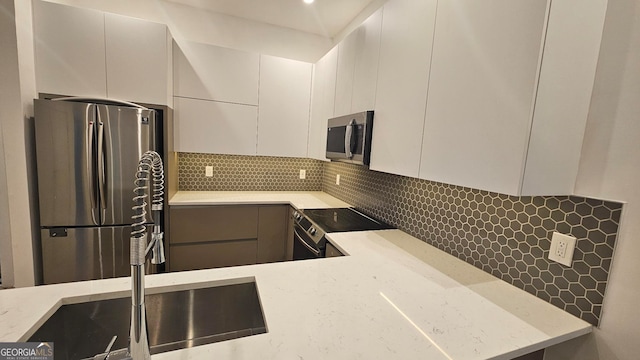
[42, 0, 333, 63]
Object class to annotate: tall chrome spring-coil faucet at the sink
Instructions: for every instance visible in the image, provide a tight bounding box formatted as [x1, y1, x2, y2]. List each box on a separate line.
[128, 151, 165, 360]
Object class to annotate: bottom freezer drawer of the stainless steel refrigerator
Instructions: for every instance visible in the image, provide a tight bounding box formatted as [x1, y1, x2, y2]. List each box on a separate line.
[41, 226, 146, 284]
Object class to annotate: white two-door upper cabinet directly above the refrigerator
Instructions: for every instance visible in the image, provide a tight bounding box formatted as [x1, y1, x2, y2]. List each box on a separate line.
[33, 1, 170, 104]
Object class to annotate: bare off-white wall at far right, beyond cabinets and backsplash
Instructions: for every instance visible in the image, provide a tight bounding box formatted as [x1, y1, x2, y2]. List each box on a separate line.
[545, 0, 640, 360]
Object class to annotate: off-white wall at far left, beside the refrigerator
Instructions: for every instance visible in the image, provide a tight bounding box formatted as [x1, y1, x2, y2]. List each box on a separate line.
[0, 0, 36, 287]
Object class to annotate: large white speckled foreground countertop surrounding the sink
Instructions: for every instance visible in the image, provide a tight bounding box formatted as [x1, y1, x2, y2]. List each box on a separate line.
[0, 195, 592, 360]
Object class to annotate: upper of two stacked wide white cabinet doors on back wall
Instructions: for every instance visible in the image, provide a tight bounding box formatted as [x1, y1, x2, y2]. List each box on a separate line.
[173, 42, 260, 105]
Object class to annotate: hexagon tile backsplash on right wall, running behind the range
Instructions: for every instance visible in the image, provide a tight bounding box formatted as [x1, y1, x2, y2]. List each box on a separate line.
[323, 163, 622, 325]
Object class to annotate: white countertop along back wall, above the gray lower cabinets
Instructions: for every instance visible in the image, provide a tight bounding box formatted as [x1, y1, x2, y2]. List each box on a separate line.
[169, 191, 351, 209]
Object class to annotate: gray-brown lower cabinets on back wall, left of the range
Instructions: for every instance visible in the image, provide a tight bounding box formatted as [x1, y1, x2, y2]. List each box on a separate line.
[169, 205, 289, 271]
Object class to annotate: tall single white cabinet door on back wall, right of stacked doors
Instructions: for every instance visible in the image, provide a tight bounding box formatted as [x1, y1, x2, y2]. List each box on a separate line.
[258, 55, 312, 157]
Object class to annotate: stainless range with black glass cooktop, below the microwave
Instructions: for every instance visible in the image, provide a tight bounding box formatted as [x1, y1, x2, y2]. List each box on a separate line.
[293, 208, 393, 260]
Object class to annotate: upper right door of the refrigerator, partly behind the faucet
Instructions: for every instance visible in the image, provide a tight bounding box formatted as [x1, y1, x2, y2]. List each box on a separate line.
[97, 105, 157, 225]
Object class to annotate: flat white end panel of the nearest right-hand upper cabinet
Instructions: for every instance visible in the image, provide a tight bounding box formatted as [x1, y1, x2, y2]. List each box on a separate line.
[521, 0, 607, 195]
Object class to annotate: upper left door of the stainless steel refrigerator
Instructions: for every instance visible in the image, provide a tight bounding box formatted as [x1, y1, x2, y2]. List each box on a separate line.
[34, 99, 99, 227]
